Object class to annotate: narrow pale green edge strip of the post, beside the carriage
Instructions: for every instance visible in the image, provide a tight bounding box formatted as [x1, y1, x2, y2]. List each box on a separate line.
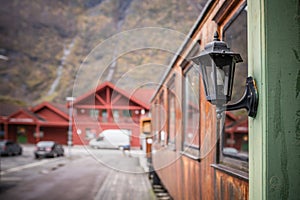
[248, 0, 267, 200]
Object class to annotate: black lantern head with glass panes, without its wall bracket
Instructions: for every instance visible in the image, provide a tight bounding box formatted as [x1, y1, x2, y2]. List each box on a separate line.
[191, 34, 243, 105]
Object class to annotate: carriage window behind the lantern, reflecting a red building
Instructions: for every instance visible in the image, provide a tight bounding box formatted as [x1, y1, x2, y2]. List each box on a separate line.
[222, 4, 248, 165]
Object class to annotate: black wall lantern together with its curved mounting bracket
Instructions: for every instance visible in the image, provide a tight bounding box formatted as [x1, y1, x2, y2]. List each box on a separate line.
[191, 32, 258, 117]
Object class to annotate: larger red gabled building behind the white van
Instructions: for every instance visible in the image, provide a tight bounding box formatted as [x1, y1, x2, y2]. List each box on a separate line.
[73, 82, 153, 147]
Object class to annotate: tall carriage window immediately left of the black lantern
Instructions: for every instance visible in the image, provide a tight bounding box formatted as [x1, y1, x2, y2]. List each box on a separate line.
[183, 67, 200, 159]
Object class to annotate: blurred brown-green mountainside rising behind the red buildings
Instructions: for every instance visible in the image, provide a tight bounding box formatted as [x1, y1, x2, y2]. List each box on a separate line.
[0, 0, 204, 104]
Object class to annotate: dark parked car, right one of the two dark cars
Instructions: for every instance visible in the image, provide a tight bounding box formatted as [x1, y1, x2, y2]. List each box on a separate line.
[34, 141, 64, 158]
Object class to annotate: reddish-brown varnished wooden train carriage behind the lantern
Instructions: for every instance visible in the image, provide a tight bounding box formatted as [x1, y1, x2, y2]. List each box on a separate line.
[152, 1, 248, 199]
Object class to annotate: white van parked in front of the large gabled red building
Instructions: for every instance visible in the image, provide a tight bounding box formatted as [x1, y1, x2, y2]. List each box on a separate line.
[89, 129, 131, 149]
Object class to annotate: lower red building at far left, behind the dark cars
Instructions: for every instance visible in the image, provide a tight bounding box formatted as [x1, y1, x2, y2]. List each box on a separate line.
[4, 102, 69, 144]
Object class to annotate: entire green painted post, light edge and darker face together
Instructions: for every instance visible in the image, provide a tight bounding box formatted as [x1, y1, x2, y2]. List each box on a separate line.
[248, 0, 300, 200]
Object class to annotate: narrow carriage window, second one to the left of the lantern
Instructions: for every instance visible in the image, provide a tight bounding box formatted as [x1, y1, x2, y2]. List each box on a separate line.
[168, 80, 176, 148]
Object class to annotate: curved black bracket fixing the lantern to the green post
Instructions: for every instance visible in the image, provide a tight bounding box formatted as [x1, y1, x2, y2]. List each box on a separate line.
[217, 76, 258, 118]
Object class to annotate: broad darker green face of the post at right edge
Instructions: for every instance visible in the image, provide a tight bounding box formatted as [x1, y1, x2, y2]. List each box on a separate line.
[265, 0, 300, 199]
